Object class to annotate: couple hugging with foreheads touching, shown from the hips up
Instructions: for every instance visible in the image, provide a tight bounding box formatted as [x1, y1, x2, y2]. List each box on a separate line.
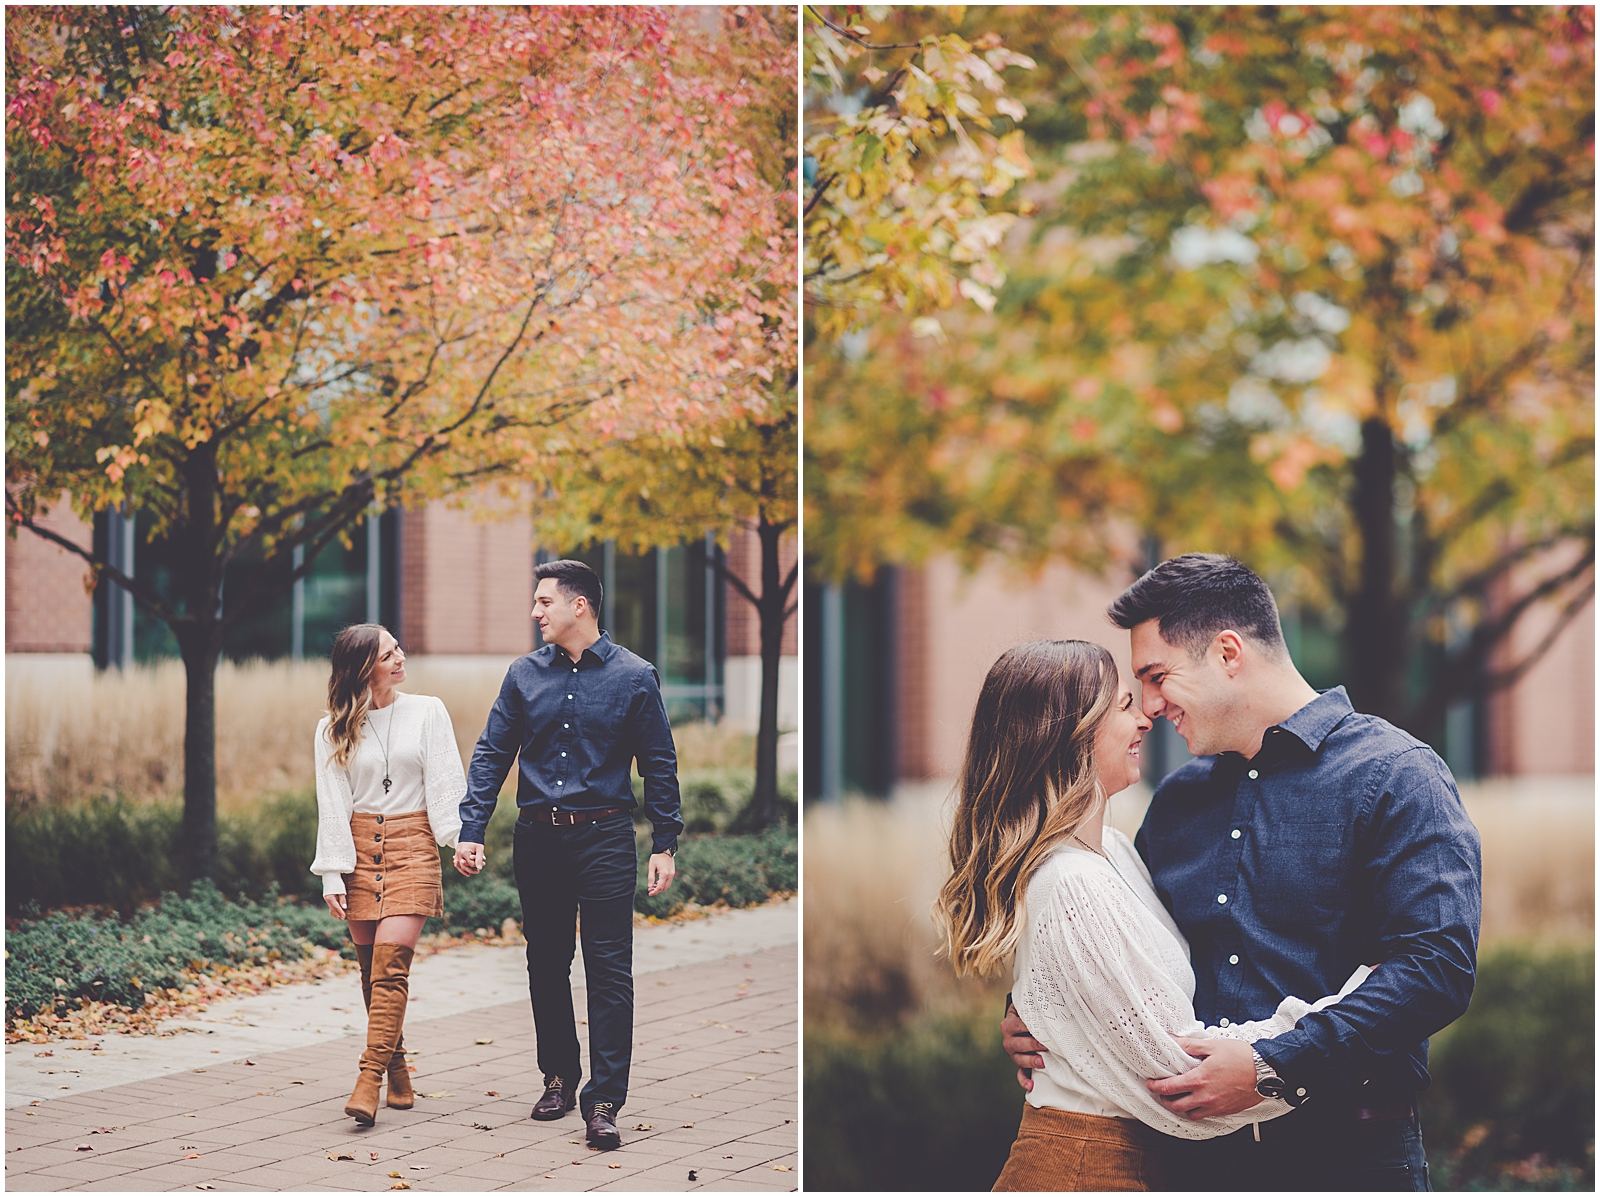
[934, 554, 1480, 1192]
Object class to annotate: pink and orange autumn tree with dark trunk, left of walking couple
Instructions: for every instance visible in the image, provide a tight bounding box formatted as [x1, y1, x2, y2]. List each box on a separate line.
[6, 8, 780, 877]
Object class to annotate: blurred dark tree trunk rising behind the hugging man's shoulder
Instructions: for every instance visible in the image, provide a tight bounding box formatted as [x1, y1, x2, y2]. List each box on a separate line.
[1344, 416, 1406, 723]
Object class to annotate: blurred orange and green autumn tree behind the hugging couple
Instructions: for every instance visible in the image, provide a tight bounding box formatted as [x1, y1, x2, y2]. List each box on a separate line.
[806, 8, 1594, 736]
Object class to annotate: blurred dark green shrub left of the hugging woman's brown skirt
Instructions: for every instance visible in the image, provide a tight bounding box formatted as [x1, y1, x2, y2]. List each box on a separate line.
[805, 1010, 1022, 1192]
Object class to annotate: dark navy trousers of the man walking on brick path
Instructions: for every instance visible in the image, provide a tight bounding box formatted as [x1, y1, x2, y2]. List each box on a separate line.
[512, 811, 638, 1117]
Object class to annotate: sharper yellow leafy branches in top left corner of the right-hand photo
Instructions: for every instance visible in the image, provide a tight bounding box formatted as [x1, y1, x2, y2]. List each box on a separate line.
[802, 5, 1034, 338]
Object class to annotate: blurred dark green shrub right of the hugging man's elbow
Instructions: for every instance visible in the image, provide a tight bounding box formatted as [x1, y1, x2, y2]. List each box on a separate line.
[1421, 947, 1595, 1191]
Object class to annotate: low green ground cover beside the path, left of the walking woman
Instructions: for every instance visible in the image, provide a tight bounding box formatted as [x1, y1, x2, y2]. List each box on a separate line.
[5, 882, 354, 1021]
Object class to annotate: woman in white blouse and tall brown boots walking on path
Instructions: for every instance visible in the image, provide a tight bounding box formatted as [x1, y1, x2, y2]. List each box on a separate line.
[310, 624, 467, 1127]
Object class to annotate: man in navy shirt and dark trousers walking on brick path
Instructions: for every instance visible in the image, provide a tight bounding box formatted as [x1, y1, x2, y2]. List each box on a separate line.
[456, 562, 683, 1149]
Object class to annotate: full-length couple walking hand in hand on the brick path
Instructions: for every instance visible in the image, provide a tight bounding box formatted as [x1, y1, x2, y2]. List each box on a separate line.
[310, 560, 683, 1149]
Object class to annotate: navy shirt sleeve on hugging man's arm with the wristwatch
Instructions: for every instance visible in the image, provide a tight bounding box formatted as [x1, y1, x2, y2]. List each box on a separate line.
[1256, 747, 1482, 1096]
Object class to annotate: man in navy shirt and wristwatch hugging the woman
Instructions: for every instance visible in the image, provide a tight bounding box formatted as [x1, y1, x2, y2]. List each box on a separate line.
[1002, 554, 1482, 1191]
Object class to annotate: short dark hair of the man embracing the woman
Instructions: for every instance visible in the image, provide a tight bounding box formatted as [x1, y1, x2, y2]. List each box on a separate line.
[1106, 552, 1288, 661]
